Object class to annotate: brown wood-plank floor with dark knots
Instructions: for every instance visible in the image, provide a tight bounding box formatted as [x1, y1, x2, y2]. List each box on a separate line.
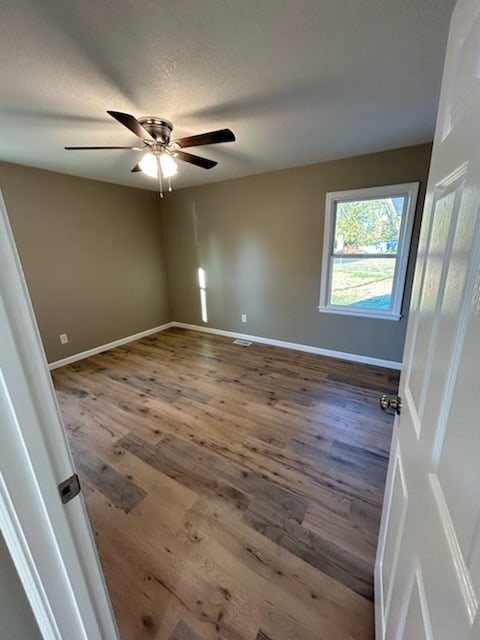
[52, 329, 398, 640]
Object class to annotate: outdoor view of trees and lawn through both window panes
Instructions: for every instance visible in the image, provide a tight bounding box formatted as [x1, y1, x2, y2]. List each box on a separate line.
[330, 196, 405, 310]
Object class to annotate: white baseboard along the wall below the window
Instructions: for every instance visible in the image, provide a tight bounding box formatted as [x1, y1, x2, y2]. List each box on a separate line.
[172, 322, 402, 370]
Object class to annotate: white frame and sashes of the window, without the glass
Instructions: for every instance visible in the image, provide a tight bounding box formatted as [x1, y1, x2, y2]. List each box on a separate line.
[318, 182, 420, 320]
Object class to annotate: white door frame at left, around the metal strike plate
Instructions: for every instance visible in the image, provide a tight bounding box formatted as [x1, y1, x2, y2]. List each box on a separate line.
[0, 195, 118, 640]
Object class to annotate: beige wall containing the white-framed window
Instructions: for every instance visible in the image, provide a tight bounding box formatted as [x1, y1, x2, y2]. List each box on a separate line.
[162, 144, 431, 361]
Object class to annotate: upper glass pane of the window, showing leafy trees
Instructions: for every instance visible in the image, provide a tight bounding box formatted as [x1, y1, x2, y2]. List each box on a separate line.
[334, 196, 405, 254]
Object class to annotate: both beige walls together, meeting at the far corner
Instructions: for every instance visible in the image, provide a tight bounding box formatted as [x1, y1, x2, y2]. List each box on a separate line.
[0, 144, 431, 362]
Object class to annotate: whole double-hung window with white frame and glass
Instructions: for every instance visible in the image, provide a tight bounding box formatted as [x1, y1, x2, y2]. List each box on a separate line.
[318, 182, 419, 320]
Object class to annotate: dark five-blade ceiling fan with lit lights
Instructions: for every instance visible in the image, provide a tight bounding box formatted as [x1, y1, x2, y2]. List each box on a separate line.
[65, 111, 235, 198]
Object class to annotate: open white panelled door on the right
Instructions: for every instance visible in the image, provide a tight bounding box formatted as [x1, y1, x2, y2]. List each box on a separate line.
[375, 0, 480, 640]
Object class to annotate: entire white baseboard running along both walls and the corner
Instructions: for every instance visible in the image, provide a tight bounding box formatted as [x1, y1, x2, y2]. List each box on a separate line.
[48, 322, 402, 370]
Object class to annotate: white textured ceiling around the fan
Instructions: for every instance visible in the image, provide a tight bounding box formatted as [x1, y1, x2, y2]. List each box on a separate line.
[0, 0, 454, 189]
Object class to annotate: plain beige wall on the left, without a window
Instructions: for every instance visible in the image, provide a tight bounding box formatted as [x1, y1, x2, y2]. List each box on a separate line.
[0, 163, 172, 362]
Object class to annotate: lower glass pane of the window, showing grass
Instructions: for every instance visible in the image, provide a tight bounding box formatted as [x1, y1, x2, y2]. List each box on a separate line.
[330, 257, 396, 311]
